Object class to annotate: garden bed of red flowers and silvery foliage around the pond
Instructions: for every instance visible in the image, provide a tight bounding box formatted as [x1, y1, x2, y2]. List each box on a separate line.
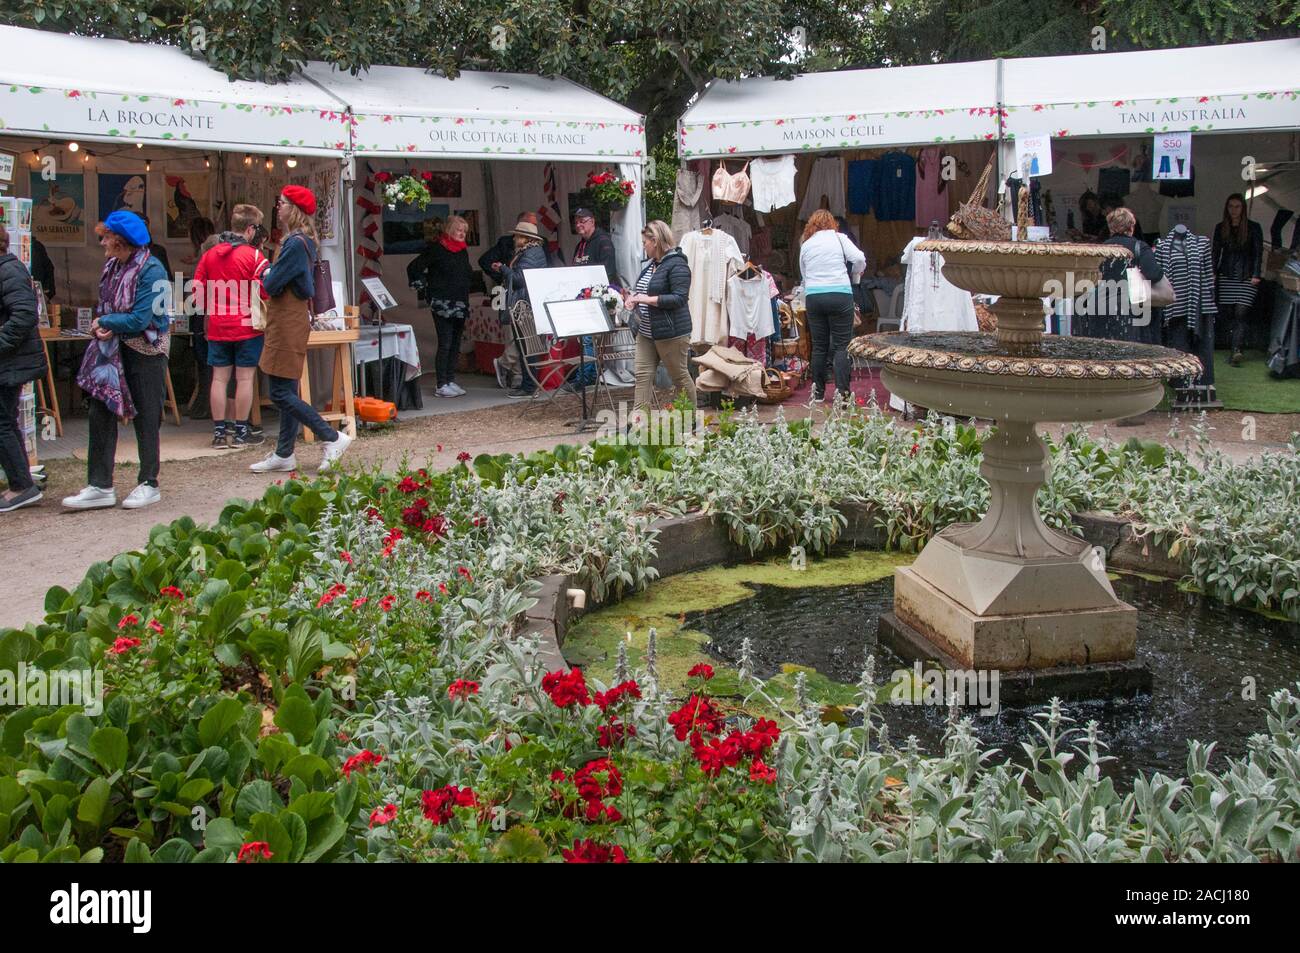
[0, 411, 1300, 863]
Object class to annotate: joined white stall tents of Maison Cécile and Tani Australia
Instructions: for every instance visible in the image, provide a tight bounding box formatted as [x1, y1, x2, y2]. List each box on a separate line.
[673, 40, 1300, 410]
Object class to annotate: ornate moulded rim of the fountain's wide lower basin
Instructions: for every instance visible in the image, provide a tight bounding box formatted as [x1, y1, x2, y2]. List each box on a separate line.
[849, 332, 1201, 381]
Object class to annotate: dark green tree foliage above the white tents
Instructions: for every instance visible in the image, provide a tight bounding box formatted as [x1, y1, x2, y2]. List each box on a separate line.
[0, 0, 1300, 140]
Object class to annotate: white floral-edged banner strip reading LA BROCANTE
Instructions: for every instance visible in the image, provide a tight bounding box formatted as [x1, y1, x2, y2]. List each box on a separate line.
[0, 86, 350, 155]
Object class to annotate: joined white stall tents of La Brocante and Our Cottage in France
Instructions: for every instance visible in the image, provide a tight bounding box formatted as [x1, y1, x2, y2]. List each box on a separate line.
[0, 21, 645, 452]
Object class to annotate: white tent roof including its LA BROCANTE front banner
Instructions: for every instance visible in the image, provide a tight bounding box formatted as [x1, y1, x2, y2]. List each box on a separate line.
[0, 26, 347, 153]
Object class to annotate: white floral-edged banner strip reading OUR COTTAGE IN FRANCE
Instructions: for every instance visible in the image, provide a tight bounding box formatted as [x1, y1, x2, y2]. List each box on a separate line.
[354, 113, 645, 160]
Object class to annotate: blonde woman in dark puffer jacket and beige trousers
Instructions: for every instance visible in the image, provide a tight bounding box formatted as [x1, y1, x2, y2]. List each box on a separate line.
[623, 221, 696, 410]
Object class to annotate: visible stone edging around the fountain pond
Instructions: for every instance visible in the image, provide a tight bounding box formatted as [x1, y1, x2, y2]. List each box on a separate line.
[519, 503, 1186, 660]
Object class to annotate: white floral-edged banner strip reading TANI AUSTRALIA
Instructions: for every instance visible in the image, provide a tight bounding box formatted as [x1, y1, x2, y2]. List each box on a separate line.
[1004, 90, 1300, 139]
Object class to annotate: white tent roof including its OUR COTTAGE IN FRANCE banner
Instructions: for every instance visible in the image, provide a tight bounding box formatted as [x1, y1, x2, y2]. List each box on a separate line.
[304, 62, 645, 161]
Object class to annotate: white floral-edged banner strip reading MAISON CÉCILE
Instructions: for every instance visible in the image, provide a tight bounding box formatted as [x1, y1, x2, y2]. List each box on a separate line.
[677, 108, 997, 159]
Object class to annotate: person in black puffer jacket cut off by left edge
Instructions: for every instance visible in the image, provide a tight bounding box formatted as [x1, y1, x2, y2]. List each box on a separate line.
[0, 228, 46, 512]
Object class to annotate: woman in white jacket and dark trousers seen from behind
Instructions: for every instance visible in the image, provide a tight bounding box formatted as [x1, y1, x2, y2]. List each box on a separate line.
[800, 208, 867, 403]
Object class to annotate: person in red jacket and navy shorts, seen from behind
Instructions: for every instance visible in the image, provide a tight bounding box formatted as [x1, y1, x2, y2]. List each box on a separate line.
[194, 205, 268, 447]
